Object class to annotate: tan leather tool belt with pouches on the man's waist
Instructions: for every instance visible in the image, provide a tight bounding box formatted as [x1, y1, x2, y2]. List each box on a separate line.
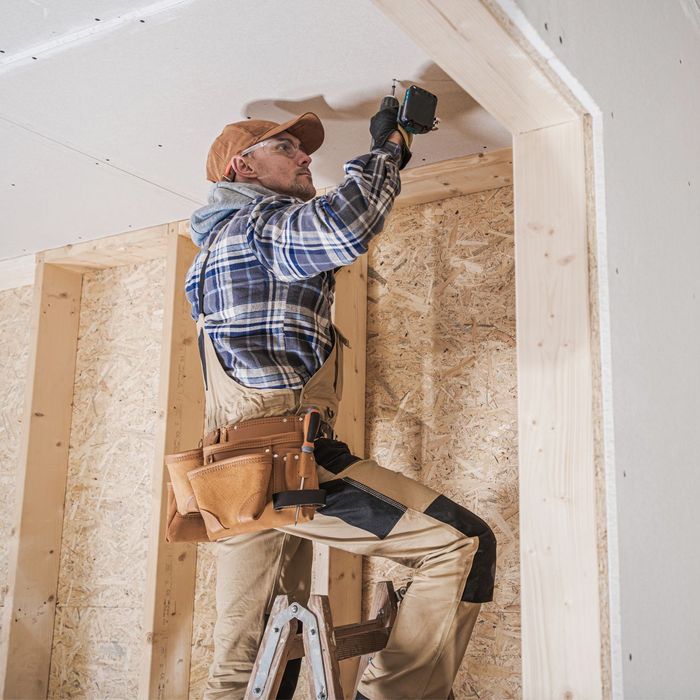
[165, 415, 325, 542]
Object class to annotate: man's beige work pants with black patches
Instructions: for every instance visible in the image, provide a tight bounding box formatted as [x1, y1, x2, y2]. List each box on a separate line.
[204, 439, 496, 700]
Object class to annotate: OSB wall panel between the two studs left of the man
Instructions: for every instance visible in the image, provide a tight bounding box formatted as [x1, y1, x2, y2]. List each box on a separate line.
[49, 260, 165, 700]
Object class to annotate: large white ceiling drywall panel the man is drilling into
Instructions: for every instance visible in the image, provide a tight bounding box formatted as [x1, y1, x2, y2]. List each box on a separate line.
[0, 0, 510, 258]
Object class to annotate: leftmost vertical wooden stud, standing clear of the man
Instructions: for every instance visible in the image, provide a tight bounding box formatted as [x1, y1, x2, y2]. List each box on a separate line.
[0, 255, 82, 700]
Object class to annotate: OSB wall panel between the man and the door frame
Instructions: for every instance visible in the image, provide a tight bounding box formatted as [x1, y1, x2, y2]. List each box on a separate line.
[364, 187, 521, 700]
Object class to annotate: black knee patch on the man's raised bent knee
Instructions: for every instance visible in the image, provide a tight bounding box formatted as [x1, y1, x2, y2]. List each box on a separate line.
[424, 496, 496, 603]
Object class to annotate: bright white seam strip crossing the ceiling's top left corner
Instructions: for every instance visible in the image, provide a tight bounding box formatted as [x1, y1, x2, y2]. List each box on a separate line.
[0, 0, 194, 75]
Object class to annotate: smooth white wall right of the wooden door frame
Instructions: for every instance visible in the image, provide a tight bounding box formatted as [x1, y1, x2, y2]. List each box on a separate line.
[508, 0, 700, 700]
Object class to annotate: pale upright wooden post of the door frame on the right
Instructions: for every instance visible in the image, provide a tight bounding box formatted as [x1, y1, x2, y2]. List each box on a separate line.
[514, 121, 601, 698]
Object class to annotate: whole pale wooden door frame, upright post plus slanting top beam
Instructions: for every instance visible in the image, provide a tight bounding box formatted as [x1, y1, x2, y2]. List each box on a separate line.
[373, 0, 612, 700]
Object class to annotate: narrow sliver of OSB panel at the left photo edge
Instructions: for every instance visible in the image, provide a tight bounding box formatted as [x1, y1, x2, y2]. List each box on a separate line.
[0, 287, 32, 620]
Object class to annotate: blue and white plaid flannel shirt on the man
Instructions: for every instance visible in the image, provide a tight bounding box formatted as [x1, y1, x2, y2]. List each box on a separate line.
[185, 143, 401, 389]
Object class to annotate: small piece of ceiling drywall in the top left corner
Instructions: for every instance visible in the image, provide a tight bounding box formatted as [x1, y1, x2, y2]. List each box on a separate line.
[0, 0, 152, 56]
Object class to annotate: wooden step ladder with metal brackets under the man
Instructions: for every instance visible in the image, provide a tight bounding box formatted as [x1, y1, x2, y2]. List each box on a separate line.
[245, 581, 405, 700]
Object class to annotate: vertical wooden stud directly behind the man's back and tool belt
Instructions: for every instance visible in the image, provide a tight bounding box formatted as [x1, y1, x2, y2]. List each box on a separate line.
[139, 224, 204, 700]
